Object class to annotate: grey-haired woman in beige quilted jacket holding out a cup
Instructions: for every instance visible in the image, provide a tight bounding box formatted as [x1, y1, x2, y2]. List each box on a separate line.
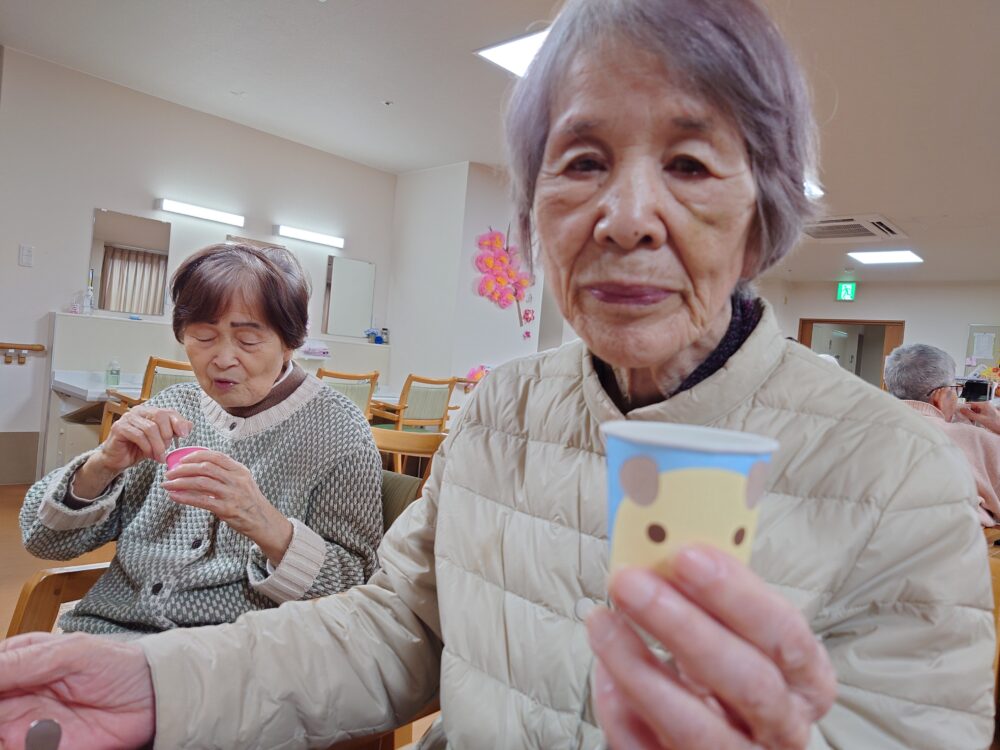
[0, 0, 994, 750]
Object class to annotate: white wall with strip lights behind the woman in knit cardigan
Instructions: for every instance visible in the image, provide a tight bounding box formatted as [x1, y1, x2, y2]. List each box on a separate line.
[0, 49, 398, 433]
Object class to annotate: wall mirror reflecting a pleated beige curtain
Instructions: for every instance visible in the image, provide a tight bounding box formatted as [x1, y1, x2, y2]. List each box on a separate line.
[90, 208, 170, 315]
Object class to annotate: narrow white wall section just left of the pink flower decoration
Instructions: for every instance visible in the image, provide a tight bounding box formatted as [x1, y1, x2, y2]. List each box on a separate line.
[385, 162, 469, 392]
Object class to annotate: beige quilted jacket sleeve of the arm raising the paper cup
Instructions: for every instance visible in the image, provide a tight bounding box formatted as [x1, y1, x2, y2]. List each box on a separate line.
[809, 443, 996, 750]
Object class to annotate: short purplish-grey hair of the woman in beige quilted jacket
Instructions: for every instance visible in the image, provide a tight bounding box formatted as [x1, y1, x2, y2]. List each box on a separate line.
[505, 0, 817, 279]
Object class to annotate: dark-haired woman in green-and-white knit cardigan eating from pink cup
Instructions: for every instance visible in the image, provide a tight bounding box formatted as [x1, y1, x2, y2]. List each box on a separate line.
[21, 245, 382, 637]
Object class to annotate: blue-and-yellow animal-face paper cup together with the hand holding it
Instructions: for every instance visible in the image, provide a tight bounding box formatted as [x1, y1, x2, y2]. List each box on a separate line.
[587, 421, 836, 750]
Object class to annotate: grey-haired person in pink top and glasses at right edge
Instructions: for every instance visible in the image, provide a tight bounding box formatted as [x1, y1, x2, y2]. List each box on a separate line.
[885, 344, 1000, 526]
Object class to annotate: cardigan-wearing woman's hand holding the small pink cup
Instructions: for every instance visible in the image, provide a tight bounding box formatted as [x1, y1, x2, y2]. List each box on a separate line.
[163, 450, 292, 565]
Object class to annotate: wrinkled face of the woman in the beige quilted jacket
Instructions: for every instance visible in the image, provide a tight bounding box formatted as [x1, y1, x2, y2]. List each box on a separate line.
[533, 43, 756, 367]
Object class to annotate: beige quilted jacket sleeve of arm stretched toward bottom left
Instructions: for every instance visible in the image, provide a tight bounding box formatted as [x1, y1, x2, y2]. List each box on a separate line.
[139, 442, 448, 750]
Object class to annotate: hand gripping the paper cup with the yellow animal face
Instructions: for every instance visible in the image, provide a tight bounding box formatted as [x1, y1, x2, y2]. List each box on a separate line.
[587, 546, 836, 750]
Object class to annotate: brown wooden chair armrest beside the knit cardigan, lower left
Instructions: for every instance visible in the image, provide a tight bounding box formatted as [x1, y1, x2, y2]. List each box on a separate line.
[7, 563, 108, 638]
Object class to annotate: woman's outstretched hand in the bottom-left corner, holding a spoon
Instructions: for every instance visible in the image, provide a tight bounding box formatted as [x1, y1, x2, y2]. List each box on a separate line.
[0, 633, 155, 750]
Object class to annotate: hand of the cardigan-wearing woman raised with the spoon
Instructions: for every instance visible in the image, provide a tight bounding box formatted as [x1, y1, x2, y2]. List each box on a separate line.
[73, 406, 192, 499]
